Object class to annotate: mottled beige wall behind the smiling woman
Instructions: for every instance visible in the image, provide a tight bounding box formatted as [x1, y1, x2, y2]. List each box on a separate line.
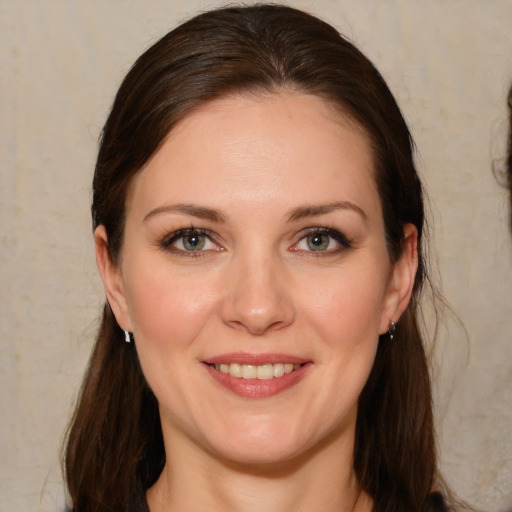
[0, 0, 512, 512]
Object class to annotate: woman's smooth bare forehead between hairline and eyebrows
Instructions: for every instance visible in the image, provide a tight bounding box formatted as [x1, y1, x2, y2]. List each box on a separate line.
[131, 92, 378, 218]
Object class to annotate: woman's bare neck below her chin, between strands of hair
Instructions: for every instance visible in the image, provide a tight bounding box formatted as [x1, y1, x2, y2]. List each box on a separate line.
[147, 424, 372, 512]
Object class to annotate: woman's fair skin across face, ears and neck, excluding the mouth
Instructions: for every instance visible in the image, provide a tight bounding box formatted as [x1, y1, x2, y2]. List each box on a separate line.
[95, 92, 417, 512]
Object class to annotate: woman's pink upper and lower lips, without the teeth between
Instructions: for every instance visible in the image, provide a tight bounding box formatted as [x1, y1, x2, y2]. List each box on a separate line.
[204, 353, 312, 398]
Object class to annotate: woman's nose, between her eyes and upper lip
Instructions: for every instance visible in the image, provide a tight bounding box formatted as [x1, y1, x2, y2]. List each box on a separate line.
[221, 249, 295, 336]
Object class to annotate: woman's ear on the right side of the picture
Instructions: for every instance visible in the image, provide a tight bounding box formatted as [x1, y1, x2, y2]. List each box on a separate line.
[379, 224, 418, 334]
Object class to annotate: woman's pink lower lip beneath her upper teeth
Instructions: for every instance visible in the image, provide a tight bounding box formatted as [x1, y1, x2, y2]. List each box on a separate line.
[205, 363, 311, 398]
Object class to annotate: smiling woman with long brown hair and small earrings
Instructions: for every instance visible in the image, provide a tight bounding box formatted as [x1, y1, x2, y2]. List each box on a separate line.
[65, 5, 452, 512]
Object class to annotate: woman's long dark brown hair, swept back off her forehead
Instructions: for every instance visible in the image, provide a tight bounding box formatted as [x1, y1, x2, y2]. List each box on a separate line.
[65, 5, 439, 512]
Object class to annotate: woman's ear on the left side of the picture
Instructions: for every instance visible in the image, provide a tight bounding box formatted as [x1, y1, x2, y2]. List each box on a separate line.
[94, 225, 133, 331]
